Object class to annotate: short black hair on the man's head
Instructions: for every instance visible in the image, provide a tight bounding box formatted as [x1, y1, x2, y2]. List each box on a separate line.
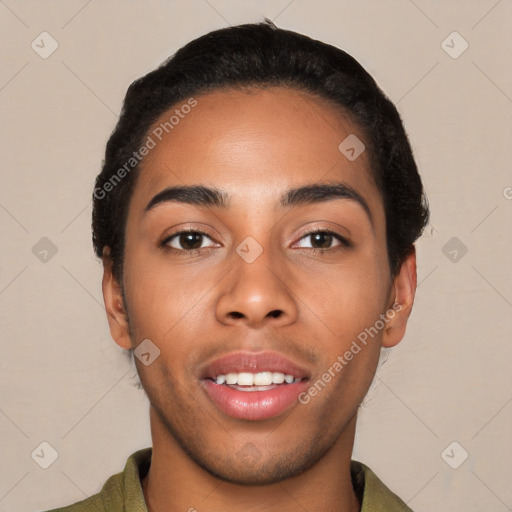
[92, 20, 429, 280]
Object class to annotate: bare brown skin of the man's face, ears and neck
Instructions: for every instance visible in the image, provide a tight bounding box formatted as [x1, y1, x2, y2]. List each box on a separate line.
[103, 88, 416, 512]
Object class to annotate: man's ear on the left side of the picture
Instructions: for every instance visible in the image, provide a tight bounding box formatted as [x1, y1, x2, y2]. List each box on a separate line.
[102, 247, 132, 349]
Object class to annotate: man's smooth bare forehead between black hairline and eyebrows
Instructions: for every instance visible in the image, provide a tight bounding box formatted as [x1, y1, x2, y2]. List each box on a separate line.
[133, 87, 380, 214]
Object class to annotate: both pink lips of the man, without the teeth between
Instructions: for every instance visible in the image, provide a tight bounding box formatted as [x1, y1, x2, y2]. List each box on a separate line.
[202, 352, 309, 421]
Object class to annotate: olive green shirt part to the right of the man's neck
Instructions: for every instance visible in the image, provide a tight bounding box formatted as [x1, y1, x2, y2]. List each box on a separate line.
[350, 460, 412, 512]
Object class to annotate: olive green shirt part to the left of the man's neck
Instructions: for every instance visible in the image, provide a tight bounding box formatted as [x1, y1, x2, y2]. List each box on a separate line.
[41, 448, 152, 512]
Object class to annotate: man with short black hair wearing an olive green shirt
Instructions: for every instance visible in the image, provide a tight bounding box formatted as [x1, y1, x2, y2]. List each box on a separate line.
[47, 22, 428, 512]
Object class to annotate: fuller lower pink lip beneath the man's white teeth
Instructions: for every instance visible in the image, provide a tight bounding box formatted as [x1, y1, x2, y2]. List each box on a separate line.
[203, 379, 308, 421]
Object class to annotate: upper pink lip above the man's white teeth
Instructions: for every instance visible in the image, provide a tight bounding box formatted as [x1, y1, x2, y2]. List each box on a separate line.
[200, 351, 309, 379]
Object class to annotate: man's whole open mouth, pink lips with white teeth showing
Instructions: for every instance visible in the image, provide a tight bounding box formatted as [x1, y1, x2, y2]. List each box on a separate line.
[201, 352, 309, 421]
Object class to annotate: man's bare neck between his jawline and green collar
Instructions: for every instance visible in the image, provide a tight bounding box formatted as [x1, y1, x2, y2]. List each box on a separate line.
[142, 407, 360, 512]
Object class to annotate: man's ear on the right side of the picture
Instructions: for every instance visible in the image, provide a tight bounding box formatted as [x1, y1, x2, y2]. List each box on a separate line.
[382, 246, 417, 348]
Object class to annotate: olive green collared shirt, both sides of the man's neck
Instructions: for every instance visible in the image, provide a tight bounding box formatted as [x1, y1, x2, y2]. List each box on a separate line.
[44, 448, 412, 512]
